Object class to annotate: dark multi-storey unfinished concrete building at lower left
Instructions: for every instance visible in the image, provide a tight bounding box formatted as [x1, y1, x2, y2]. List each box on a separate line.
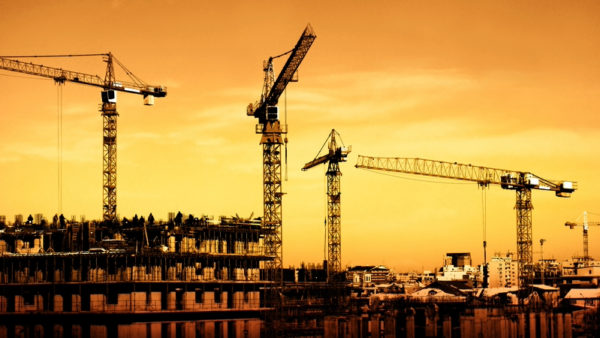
[0, 214, 272, 337]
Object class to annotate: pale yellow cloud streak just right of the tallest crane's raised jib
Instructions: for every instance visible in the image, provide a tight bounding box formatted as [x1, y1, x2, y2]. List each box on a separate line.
[280, 70, 477, 123]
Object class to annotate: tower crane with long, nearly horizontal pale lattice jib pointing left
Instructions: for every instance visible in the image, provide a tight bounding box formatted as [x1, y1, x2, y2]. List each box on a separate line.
[356, 155, 577, 288]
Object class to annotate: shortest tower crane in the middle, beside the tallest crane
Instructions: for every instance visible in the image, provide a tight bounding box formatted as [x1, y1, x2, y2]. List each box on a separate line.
[302, 129, 352, 282]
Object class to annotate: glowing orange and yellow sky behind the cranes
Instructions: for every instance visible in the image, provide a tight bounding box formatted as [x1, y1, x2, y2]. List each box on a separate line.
[0, 1, 600, 270]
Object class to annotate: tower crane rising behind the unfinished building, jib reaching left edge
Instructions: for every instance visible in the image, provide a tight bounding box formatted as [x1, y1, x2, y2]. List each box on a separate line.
[0, 52, 167, 222]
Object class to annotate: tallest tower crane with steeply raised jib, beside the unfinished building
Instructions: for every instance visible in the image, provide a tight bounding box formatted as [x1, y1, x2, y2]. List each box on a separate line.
[246, 25, 316, 281]
